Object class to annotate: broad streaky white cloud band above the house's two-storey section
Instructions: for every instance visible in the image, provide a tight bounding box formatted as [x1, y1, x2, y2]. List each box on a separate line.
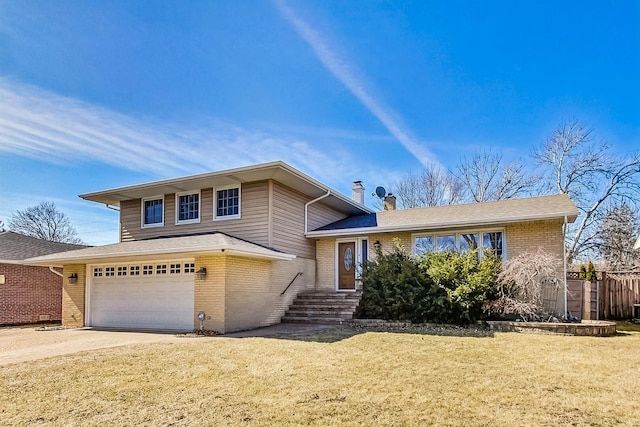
[0, 78, 360, 178]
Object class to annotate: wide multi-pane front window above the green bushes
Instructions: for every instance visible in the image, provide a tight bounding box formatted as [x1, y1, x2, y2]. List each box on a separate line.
[413, 230, 505, 258]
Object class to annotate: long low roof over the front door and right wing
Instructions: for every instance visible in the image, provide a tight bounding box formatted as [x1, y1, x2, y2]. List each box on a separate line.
[307, 194, 578, 237]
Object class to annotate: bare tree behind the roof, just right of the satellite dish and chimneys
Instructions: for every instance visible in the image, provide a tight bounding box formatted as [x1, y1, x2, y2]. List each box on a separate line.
[392, 166, 463, 209]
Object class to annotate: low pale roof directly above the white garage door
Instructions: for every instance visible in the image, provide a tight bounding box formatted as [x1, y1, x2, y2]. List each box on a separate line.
[25, 232, 296, 266]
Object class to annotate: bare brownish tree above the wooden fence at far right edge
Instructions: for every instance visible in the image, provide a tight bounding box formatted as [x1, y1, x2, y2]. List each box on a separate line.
[598, 204, 640, 271]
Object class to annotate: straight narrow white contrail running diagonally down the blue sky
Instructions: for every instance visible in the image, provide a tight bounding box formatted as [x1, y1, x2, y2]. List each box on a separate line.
[274, 0, 437, 171]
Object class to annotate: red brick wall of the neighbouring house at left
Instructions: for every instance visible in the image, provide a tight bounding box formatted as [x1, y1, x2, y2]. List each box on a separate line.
[0, 264, 62, 325]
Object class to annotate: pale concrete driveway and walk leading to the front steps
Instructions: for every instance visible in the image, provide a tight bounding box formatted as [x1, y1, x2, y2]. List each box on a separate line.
[0, 324, 337, 366]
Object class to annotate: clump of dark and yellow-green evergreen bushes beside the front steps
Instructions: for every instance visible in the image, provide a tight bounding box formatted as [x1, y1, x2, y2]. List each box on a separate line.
[358, 248, 500, 324]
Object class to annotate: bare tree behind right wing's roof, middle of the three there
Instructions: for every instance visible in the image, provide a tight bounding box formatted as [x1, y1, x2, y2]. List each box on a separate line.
[454, 150, 539, 202]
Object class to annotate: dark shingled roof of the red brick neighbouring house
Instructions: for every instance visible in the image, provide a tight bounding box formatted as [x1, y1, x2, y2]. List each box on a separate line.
[0, 231, 87, 264]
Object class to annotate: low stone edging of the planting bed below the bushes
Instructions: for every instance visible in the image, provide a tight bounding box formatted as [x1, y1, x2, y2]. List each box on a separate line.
[346, 319, 616, 337]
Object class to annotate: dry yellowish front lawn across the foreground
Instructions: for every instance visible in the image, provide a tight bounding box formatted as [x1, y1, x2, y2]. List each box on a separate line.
[0, 328, 640, 426]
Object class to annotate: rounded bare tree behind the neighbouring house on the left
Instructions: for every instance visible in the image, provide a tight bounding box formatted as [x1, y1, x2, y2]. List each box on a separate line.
[9, 202, 82, 244]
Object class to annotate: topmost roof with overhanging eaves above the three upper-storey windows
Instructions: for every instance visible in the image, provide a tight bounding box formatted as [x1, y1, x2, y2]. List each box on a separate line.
[80, 161, 373, 215]
